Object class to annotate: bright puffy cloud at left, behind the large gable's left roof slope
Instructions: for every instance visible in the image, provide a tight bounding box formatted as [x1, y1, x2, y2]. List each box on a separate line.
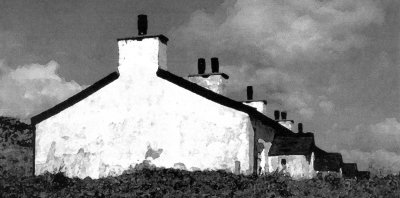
[0, 61, 83, 119]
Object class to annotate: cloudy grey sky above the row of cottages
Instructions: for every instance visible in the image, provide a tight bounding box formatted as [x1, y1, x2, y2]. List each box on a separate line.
[0, 0, 400, 172]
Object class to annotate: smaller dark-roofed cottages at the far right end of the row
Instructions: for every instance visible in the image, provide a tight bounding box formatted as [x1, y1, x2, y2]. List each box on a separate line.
[268, 111, 370, 179]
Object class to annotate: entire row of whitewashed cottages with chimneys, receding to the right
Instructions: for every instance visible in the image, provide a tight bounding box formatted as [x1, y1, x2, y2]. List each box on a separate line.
[31, 15, 366, 178]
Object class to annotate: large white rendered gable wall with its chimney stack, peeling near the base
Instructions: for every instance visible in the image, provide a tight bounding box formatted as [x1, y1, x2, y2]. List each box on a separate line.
[35, 38, 253, 178]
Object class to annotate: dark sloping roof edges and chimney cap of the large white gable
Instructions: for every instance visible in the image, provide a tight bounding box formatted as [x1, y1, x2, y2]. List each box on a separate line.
[31, 35, 293, 135]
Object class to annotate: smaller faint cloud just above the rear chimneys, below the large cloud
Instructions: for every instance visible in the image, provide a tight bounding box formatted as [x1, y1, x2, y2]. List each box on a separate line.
[221, 64, 319, 119]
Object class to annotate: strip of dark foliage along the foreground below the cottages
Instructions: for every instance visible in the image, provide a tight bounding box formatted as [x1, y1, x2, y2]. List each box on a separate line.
[0, 169, 400, 197]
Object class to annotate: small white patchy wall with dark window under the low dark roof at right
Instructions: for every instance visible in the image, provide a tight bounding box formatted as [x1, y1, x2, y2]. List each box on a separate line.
[268, 153, 315, 179]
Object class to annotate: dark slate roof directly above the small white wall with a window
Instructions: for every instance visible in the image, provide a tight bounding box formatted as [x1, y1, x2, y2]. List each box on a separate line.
[268, 135, 315, 156]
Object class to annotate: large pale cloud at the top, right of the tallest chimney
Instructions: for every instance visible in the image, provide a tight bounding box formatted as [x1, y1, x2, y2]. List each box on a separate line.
[174, 0, 384, 65]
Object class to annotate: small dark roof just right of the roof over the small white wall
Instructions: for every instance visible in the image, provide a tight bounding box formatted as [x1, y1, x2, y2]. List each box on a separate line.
[314, 152, 343, 172]
